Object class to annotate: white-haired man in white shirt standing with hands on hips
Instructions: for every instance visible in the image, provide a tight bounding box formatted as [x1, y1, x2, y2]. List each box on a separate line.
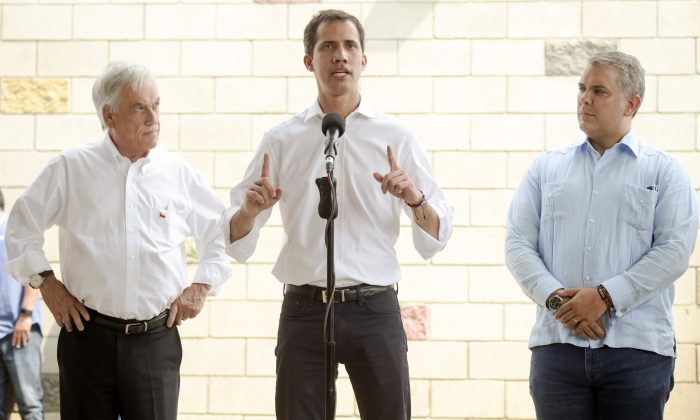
[5, 62, 231, 420]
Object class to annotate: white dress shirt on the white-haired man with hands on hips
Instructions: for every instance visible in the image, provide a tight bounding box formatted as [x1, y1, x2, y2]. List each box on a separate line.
[5, 135, 231, 320]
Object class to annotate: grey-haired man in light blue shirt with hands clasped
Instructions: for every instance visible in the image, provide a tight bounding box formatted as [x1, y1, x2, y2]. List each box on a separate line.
[506, 52, 698, 420]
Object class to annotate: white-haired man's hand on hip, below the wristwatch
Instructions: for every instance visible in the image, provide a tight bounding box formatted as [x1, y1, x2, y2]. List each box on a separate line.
[39, 275, 90, 332]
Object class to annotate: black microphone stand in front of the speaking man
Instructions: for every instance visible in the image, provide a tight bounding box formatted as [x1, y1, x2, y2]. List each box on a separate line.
[316, 169, 338, 420]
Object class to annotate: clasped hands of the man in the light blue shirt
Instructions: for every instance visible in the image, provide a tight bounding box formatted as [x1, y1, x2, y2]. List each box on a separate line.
[554, 287, 608, 330]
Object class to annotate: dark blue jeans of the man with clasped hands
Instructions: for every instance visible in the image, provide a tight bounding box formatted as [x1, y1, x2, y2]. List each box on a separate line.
[530, 344, 675, 420]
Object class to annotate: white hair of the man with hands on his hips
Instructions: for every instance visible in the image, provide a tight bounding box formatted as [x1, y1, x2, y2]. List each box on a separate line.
[92, 61, 155, 129]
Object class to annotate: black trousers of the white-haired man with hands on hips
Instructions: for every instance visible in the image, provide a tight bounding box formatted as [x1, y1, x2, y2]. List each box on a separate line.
[57, 316, 182, 420]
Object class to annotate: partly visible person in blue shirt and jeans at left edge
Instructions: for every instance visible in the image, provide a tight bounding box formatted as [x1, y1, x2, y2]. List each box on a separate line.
[0, 191, 44, 420]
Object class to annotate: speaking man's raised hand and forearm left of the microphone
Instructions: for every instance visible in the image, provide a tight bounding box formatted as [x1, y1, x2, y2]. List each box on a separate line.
[230, 153, 282, 242]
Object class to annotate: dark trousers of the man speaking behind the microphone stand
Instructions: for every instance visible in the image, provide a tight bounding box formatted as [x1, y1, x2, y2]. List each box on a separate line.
[275, 291, 411, 420]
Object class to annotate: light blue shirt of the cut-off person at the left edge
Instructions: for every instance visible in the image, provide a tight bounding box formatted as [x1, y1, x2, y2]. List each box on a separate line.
[0, 213, 41, 338]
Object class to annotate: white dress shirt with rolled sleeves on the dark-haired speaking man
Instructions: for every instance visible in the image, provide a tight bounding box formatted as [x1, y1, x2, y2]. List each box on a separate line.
[223, 101, 453, 287]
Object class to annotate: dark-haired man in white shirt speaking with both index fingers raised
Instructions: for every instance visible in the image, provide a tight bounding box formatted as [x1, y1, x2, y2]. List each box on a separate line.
[224, 10, 452, 420]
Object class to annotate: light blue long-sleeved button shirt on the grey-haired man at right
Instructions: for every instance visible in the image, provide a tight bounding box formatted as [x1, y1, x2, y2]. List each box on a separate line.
[506, 131, 698, 356]
